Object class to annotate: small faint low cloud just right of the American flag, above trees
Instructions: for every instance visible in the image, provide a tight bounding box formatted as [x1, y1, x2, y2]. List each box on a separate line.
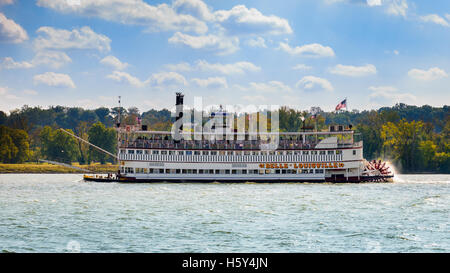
[369, 86, 417, 104]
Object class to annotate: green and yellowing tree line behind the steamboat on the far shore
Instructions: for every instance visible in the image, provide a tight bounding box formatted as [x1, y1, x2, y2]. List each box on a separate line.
[0, 104, 450, 173]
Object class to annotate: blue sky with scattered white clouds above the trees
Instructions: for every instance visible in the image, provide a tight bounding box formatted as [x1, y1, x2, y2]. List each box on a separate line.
[0, 0, 450, 112]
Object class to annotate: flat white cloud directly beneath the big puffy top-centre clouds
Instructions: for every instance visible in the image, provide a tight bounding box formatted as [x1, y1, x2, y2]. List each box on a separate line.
[169, 32, 239, 55]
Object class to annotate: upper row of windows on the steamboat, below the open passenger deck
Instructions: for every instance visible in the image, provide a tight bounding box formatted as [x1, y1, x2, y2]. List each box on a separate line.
[120, 150, 342, 155]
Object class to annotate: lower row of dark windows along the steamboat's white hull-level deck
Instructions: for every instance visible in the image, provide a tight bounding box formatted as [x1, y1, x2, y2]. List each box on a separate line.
[121, 167, 324, 174]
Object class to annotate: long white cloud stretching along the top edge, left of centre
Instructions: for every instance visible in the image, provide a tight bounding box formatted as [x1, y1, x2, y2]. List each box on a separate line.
[37, 0, 208, 33]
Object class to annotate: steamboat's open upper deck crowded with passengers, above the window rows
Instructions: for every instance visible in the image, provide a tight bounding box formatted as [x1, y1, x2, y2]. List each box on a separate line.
[119, 130, 362, 150]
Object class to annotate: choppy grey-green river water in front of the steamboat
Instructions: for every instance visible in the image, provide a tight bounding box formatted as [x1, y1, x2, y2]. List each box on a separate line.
[0, 174, 450, 252]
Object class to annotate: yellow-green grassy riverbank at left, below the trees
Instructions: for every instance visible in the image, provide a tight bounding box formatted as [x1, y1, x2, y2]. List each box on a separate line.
[0, 163, 117, 173]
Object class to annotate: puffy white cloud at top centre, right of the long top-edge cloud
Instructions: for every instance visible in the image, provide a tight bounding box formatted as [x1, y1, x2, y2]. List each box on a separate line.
[214, 5, 292, 34]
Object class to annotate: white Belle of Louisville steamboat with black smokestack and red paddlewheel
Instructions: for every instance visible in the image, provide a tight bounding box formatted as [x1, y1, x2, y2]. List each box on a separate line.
[84, 93, 394, 183]
